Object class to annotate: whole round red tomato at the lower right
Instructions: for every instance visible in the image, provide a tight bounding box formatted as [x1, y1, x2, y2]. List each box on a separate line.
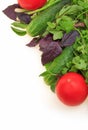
[55, 72, 88, 106]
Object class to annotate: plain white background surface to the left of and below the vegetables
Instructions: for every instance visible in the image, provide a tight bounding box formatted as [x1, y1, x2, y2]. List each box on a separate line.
[0, 0, 88, 130]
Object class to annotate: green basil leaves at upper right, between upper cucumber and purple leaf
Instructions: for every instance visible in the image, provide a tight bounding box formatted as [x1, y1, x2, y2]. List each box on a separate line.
[45, 0, 88, 40]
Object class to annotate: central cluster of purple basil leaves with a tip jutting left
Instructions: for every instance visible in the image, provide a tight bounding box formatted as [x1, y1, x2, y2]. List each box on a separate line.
[27, 34, 62, 65]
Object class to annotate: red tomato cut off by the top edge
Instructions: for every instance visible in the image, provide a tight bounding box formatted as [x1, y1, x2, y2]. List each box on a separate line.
[18, 0, 47, 10]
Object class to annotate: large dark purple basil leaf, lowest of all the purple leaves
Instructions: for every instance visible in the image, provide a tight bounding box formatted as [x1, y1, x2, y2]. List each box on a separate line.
[41, 41, 62, 65]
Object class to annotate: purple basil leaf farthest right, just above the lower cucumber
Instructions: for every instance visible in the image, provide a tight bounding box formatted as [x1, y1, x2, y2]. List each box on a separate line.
[60, 30, 80, 47]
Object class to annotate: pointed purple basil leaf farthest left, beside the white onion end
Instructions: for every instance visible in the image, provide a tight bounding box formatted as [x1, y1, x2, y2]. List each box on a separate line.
[3, 4, 20, 21]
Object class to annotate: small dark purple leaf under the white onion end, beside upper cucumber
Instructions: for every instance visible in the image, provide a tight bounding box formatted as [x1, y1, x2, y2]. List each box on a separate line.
[17, 13, 31, 24]
